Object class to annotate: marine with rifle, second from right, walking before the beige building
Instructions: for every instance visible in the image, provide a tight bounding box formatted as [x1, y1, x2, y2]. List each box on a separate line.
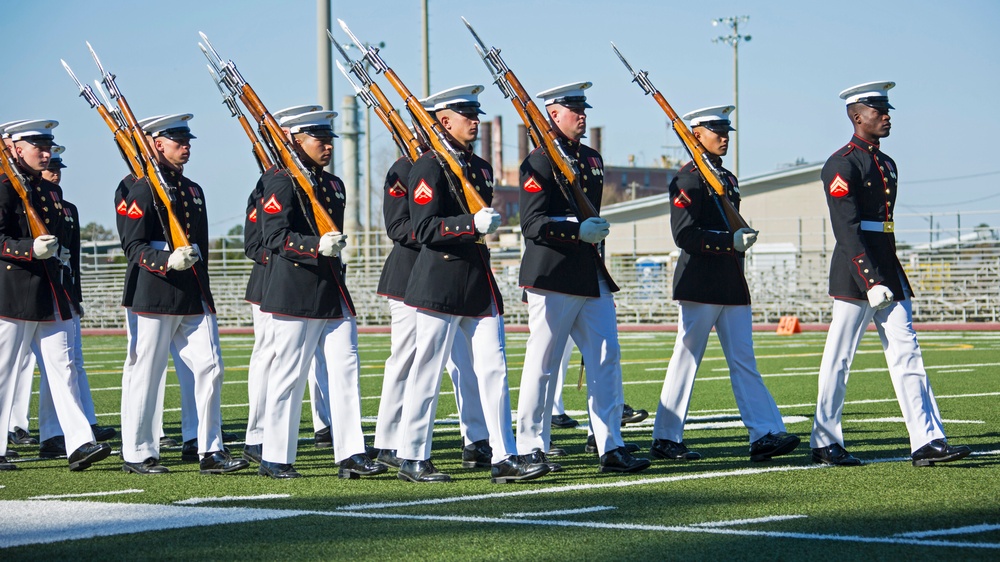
[651, 105, 799, 461]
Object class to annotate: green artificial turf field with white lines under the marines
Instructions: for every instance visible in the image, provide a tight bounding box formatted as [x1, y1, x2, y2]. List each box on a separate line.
[0, 332, 1000, 560]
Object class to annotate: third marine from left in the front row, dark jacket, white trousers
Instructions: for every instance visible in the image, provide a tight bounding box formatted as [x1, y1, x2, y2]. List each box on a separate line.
[257, 111, 386, 478]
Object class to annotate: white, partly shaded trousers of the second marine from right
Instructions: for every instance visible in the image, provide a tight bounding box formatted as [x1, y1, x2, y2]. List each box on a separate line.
[652, 301, 785, 443]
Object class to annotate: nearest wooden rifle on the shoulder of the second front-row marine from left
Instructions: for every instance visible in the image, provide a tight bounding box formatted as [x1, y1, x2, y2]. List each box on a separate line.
[85, 42, 191, 247]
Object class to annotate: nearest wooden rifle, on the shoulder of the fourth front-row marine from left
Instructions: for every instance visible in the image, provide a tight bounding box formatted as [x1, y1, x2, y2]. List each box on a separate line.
[337, 19, 487, 214]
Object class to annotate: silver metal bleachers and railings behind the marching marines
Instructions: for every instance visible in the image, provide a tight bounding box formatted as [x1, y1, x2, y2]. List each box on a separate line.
[83, 211, 1000, 328]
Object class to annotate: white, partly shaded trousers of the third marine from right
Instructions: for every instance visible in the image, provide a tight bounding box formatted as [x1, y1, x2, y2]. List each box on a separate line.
[517, 279, 625, 455]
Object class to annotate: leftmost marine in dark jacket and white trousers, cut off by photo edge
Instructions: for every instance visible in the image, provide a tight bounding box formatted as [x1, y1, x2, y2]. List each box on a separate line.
[0, 120, 111, 471]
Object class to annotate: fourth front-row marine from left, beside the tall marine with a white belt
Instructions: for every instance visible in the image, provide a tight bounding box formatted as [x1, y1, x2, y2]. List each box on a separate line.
[397, 85, 549, 483]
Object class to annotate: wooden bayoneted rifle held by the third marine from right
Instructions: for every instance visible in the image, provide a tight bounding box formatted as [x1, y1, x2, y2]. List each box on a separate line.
[462, 18, 598, 222]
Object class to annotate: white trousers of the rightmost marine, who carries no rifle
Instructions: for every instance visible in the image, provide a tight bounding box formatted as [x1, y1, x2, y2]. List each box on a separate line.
[809, 298, 944, 451]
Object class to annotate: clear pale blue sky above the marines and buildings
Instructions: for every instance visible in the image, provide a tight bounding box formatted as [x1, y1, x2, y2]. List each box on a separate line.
[0, 0, 1000, 235]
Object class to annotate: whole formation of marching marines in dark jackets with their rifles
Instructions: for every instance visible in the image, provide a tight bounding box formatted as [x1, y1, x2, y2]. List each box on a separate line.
[0, 26, 971, 476]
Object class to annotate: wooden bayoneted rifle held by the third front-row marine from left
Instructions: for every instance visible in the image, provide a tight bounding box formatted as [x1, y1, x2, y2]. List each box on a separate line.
[198, 31, 340, 236]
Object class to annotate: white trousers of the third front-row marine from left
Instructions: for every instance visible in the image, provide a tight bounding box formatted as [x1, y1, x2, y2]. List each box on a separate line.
[263, 303, 365, 464]
